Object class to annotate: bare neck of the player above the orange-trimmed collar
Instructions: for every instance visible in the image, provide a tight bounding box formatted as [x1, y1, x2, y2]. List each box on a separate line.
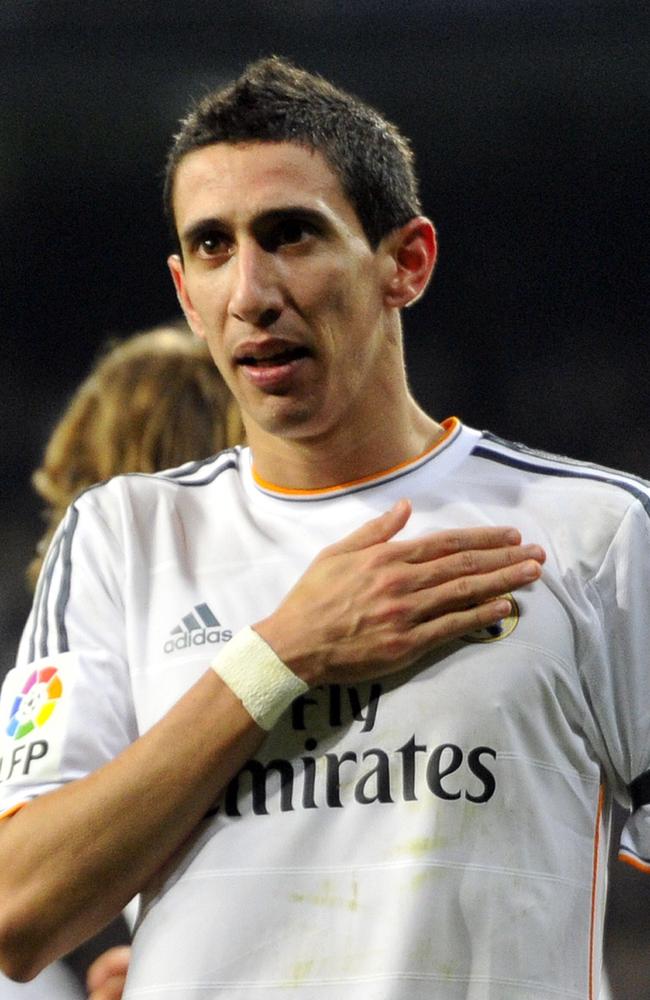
[247, 397, 445, 490]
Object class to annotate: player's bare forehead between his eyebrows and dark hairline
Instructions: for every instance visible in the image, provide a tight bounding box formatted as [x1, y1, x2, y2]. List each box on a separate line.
[173, 142, 361, 231]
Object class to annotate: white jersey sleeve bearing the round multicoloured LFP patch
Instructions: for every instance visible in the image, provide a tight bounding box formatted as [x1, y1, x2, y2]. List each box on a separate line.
[0, 491, 137, 816]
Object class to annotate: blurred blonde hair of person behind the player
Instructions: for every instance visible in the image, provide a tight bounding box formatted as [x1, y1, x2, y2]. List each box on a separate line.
[27, 321, 244, 587]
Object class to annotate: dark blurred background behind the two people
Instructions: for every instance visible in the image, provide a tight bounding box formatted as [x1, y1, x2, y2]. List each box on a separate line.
[0, 0, 650, 1000]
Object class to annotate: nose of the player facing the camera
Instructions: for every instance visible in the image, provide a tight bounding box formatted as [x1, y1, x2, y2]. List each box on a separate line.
[229, 241, 283, 328]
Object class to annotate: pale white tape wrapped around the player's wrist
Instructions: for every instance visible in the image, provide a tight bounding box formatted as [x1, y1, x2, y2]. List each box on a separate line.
[210, 625, 309, 731]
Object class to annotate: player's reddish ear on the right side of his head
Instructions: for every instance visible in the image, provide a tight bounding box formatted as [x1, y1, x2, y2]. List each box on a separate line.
[384, 215, 438, 309]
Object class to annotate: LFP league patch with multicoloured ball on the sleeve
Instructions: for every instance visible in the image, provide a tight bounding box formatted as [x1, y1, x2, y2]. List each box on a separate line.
[0, 653, 79, 786]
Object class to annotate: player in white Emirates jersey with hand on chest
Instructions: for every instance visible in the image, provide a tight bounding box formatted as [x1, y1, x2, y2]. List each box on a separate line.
[0, 60, 650, 1000]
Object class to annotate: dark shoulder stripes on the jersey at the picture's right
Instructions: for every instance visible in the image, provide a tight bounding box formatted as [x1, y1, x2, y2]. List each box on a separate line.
[472, 433, 650, 516]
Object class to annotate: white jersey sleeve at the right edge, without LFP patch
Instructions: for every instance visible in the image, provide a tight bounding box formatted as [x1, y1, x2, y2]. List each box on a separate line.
[586, 504, 650, 872]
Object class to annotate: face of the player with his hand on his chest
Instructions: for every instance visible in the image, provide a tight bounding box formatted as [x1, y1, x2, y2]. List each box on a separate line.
[169, 142, 401, 442]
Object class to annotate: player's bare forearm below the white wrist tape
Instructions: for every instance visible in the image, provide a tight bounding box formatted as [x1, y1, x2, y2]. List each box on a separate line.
[0, 671, 264, 978]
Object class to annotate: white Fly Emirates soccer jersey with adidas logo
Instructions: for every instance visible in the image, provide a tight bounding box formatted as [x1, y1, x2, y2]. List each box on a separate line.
[0, 421, 650, 1000]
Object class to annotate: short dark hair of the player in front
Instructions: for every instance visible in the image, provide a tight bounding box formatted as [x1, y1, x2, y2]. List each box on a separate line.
[164, 56, 421, 249]
